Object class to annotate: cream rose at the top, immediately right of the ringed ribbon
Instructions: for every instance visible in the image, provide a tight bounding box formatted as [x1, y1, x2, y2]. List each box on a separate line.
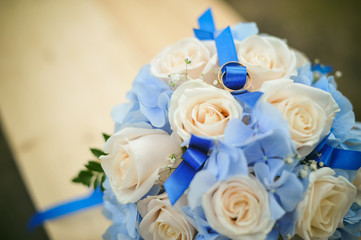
[236, 35, 297, 91]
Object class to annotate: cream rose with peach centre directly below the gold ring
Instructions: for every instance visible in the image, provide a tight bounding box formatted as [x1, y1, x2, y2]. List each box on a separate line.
[168, 80, 242, 140]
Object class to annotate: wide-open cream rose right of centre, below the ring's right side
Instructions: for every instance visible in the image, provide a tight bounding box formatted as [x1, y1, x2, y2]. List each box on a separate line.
[260, 79, 340, 156]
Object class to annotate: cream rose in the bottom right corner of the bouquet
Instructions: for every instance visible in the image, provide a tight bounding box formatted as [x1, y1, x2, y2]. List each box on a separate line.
[295, 167, 356, 240]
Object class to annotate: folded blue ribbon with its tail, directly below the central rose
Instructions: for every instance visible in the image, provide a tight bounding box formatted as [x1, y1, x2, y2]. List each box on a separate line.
[164, 135, 213, 205]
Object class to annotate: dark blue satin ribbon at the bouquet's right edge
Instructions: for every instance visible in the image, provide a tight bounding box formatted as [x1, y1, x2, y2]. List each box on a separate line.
[307, 135, 361, 170]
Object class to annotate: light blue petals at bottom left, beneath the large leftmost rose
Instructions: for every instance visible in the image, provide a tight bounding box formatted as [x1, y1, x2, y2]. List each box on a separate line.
[103, 179, 141, 240]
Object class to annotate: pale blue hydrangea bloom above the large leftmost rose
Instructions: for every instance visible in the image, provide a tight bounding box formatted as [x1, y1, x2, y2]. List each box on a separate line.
[112, 65, 172, 132]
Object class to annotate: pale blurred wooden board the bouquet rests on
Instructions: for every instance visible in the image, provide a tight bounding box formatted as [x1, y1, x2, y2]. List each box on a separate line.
[0, 0, 240, 240]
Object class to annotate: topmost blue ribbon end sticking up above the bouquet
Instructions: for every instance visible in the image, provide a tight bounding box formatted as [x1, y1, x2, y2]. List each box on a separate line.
[193, 8, 216, 40]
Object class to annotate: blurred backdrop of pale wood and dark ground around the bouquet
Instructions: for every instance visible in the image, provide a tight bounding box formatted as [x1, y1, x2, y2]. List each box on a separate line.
[0, 0, 361, 239]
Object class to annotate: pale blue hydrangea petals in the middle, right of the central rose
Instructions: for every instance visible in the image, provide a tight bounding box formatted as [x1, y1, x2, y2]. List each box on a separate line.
[224, 103, 298, 166]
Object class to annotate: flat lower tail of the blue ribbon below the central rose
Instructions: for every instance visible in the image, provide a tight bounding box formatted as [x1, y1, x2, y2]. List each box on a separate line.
[164, 161, 196, 205]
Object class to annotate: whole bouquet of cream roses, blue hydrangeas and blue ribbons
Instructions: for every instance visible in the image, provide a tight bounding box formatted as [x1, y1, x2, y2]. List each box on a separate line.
[73, 10, 361, 240]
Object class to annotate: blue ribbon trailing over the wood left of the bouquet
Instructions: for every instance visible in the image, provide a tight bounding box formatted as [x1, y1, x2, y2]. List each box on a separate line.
[28, 187, 103, 231]
